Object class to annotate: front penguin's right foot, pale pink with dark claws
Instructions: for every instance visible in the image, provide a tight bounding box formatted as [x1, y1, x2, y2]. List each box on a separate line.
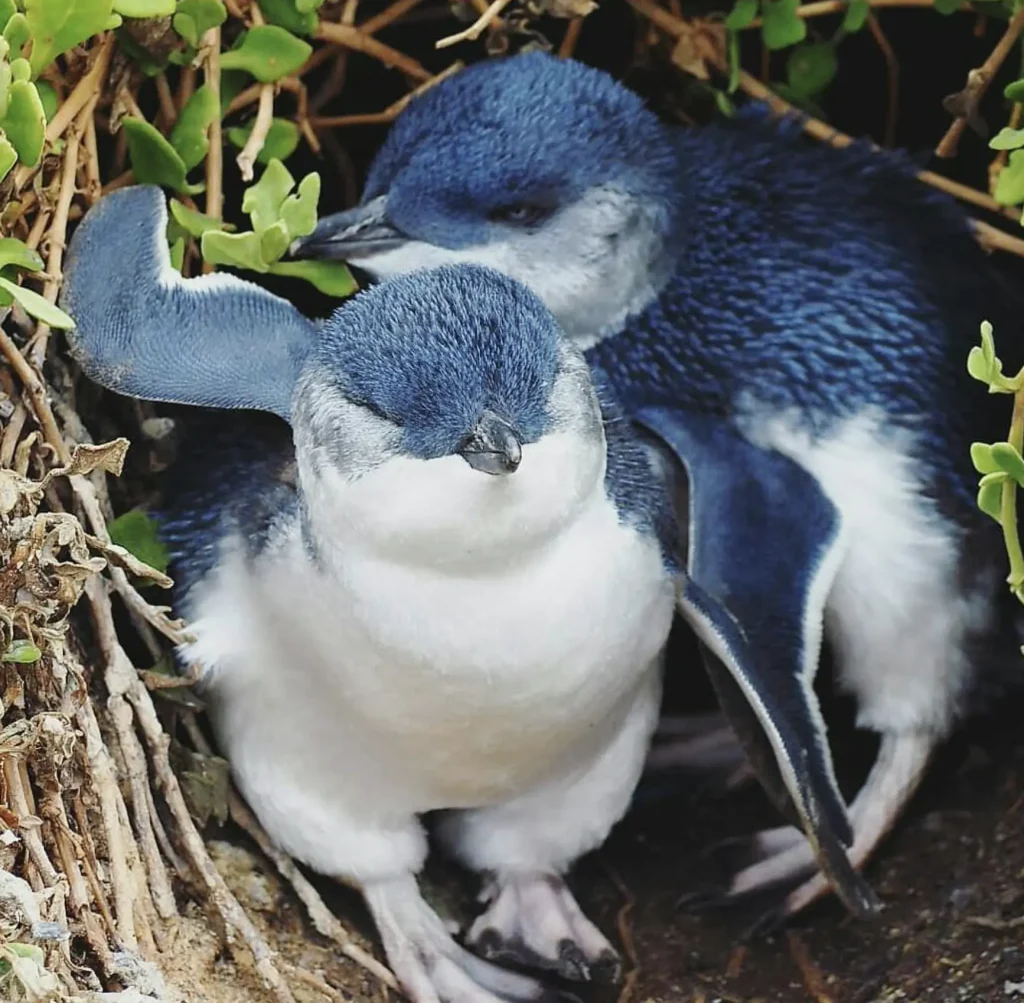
[466, 873, 621, 983]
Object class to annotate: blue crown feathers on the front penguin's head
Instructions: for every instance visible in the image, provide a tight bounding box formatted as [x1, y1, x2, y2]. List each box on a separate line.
[308, 264, 562, 459]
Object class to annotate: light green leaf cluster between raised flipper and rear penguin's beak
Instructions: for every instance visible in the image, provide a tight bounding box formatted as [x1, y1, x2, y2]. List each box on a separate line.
[200, 160, 355, 298]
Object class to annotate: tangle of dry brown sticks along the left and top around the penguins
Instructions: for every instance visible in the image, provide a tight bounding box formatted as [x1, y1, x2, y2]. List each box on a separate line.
[0, 0, 1024, 1003]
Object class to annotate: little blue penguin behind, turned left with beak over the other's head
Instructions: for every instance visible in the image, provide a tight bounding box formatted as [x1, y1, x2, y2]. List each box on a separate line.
[292, 53, 1022, 914]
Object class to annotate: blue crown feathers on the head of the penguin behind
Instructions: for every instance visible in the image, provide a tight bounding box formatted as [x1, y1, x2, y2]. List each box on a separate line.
[364, 52, 673, 247]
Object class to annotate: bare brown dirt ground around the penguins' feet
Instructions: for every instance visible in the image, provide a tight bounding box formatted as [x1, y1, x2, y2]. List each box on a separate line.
[151, 672, 1024, 1003]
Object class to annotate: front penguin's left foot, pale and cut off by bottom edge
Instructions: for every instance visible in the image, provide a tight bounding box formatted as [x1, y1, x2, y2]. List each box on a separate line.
[362, 875, 580, 1003]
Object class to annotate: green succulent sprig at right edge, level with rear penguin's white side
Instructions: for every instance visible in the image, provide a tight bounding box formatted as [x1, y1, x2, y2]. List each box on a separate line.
[967, 321, 1024, 602]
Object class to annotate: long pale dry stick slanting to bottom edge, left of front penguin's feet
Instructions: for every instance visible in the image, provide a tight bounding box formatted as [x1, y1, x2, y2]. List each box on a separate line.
[85, 576, 295, 1003]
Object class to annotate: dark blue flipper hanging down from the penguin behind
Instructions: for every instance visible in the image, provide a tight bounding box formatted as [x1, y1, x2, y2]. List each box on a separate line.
[634, 408, 879, 915]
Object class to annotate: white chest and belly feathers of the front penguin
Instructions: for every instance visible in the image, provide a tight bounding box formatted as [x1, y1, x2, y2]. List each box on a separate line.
[182, 438, 674, 811]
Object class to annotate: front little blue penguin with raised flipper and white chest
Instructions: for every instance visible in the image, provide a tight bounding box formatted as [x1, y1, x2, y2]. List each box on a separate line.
[61, 186, 677, 1003]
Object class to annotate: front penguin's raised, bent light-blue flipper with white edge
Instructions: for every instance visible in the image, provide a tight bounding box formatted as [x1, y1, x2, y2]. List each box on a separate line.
[60, 185, 316, 419]
